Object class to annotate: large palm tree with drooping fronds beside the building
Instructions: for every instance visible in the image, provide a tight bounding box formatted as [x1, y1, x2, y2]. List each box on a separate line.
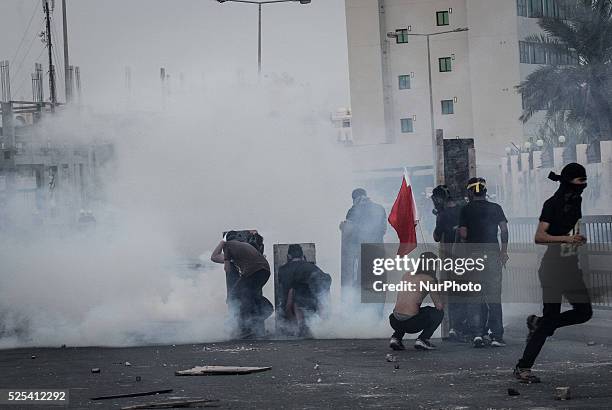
[517, 0, 612, 147]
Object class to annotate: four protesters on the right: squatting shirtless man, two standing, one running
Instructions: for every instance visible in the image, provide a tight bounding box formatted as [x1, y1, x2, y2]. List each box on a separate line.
[389, 163, 593, 383]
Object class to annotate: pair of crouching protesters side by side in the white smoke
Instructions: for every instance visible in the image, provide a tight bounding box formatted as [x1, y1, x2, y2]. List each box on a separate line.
[211, 231, 331, 339]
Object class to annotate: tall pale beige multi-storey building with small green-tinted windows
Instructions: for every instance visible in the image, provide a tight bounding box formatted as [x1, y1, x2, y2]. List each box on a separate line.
[346, 0, 562, 184]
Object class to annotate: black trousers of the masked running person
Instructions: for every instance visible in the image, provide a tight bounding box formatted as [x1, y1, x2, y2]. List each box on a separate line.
[518, 258, 593, 369]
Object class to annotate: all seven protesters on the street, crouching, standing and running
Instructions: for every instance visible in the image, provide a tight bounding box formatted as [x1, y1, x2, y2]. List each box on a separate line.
[211, 163, 592, 382]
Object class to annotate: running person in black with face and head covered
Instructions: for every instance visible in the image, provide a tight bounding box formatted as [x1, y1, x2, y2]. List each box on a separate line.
[514, 163, 593, 383]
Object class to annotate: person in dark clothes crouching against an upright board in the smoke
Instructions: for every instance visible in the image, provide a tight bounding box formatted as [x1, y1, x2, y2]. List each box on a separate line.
[277, 245, 331, 338]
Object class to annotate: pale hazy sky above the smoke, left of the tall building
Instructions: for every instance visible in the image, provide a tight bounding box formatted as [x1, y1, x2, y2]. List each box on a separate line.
[0, 0, 348, 106]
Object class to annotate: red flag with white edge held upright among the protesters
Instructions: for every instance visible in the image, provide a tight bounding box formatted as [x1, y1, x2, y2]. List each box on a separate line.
[389, 172, 418, 256]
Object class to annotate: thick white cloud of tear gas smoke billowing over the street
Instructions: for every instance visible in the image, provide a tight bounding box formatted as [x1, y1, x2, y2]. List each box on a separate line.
[0, 73, 392, 347]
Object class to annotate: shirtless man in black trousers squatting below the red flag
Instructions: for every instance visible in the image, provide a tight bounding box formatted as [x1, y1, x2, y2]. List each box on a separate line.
[389, 252, 444, 350]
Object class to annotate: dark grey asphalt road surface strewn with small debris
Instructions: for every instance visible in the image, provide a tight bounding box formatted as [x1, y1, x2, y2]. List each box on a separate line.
[0, 324, 612, 409]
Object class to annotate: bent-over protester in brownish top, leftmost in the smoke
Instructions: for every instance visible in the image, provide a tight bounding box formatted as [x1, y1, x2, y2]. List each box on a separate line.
[211, 231, 274, 339]
